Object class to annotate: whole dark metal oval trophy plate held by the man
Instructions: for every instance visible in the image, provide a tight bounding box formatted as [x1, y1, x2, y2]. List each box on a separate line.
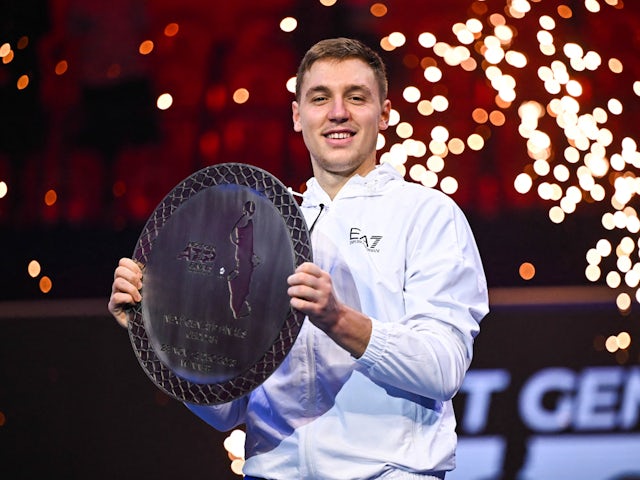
[129, 163, 312, 405]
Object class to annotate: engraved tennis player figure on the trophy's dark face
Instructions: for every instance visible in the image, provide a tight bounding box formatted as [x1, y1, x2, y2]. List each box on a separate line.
[227, 200, 260, 319]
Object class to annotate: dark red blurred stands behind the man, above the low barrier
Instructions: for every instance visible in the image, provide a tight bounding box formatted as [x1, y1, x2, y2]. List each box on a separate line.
[0, 0, 640, 300]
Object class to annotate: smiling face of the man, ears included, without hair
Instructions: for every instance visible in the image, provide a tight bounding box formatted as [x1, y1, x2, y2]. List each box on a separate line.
[292, 59, 391, 181]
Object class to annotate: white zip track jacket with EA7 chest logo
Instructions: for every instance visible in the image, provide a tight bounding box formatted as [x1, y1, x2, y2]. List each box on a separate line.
[188, 164, 488, 480]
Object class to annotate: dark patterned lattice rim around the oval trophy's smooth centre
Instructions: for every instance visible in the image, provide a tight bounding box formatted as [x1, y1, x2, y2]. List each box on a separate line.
[128, 163, 312, 405]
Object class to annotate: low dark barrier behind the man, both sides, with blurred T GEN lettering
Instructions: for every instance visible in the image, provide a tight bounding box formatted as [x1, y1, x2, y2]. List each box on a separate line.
[0, 288, 640, 480]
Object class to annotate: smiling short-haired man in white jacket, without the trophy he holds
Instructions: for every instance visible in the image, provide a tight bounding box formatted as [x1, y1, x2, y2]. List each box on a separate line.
[109, 38, 488, 480]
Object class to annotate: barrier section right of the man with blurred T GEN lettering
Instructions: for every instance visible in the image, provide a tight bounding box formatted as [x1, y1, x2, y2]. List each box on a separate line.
[447, 288, 640, 480]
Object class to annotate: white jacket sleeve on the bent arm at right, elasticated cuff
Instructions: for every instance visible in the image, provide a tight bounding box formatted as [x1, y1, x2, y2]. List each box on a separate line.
[358, 198, 489, 401]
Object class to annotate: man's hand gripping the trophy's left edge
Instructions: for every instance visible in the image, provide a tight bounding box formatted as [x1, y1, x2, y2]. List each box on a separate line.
[108, 258, 142, 327]
